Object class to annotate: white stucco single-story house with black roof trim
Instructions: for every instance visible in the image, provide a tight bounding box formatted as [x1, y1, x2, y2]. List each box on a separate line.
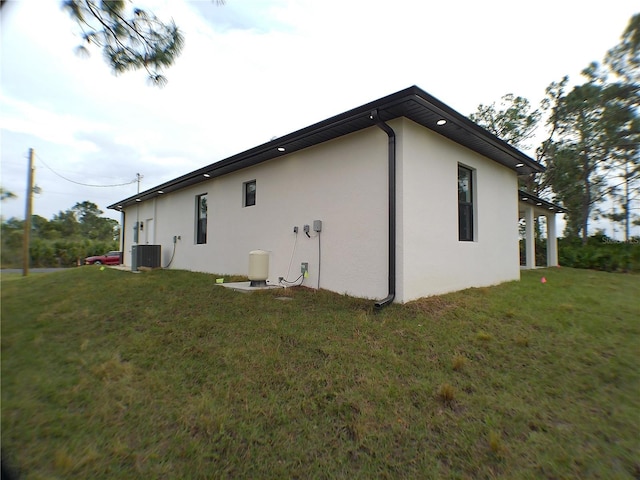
[109, 86, 557, 306]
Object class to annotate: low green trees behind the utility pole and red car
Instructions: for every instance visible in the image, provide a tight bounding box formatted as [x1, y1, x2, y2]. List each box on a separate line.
[1, 201, 120, 268]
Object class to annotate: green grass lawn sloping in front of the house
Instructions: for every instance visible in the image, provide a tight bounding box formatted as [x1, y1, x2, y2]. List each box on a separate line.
[2, 267, 640, 479]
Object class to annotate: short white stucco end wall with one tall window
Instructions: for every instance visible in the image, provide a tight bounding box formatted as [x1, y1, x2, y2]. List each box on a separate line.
[396, 119, 520, 302]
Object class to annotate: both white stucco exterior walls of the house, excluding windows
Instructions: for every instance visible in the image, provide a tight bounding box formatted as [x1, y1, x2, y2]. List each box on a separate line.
[124, 118, 520, 302]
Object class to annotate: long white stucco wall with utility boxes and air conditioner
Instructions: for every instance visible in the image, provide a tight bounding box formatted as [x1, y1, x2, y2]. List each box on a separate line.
[124, 126, 388, 298]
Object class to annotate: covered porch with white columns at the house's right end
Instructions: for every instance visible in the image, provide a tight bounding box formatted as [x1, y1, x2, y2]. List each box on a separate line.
[518, 190, 566, 269]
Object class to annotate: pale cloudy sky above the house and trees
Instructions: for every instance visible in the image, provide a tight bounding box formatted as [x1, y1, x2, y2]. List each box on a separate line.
[0, 0, 636, 237]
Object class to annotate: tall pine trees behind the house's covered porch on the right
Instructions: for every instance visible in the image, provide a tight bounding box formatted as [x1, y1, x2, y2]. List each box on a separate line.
[470, 14, 640, 245]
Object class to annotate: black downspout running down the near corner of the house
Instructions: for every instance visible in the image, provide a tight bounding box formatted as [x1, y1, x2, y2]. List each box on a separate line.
[369, 110, 396, 310]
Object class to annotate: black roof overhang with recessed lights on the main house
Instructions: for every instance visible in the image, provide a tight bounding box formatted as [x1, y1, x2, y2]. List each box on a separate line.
[107, 86, 544, 210]
